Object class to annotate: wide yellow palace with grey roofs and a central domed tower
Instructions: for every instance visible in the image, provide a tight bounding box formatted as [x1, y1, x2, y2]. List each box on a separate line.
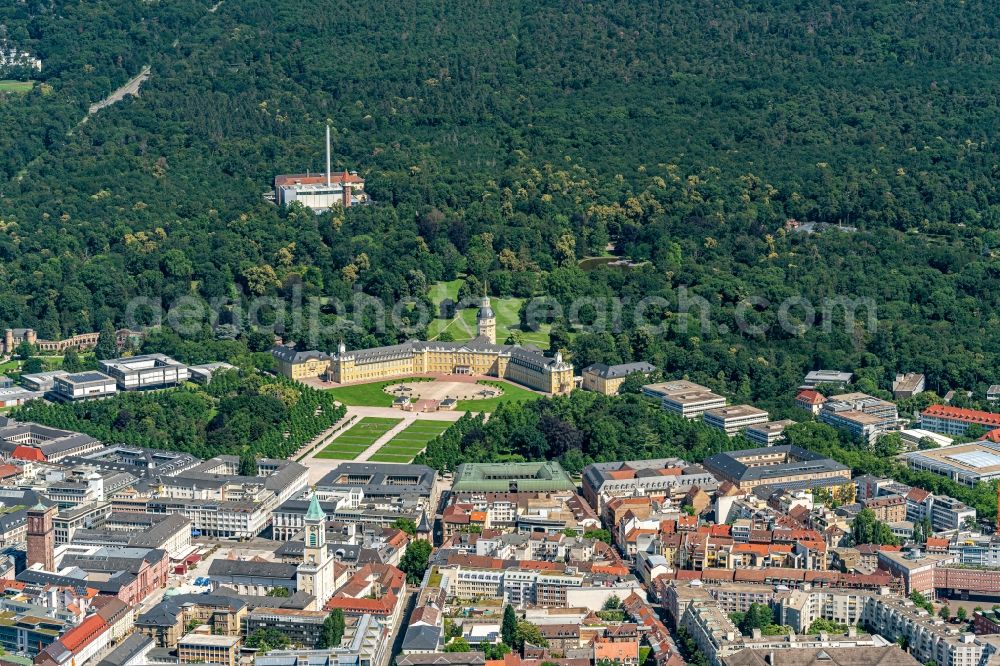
[326, 297, 573, 394]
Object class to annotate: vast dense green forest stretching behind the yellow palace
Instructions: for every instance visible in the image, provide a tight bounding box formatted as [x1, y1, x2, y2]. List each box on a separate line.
[0, 0, 1000, 400]
